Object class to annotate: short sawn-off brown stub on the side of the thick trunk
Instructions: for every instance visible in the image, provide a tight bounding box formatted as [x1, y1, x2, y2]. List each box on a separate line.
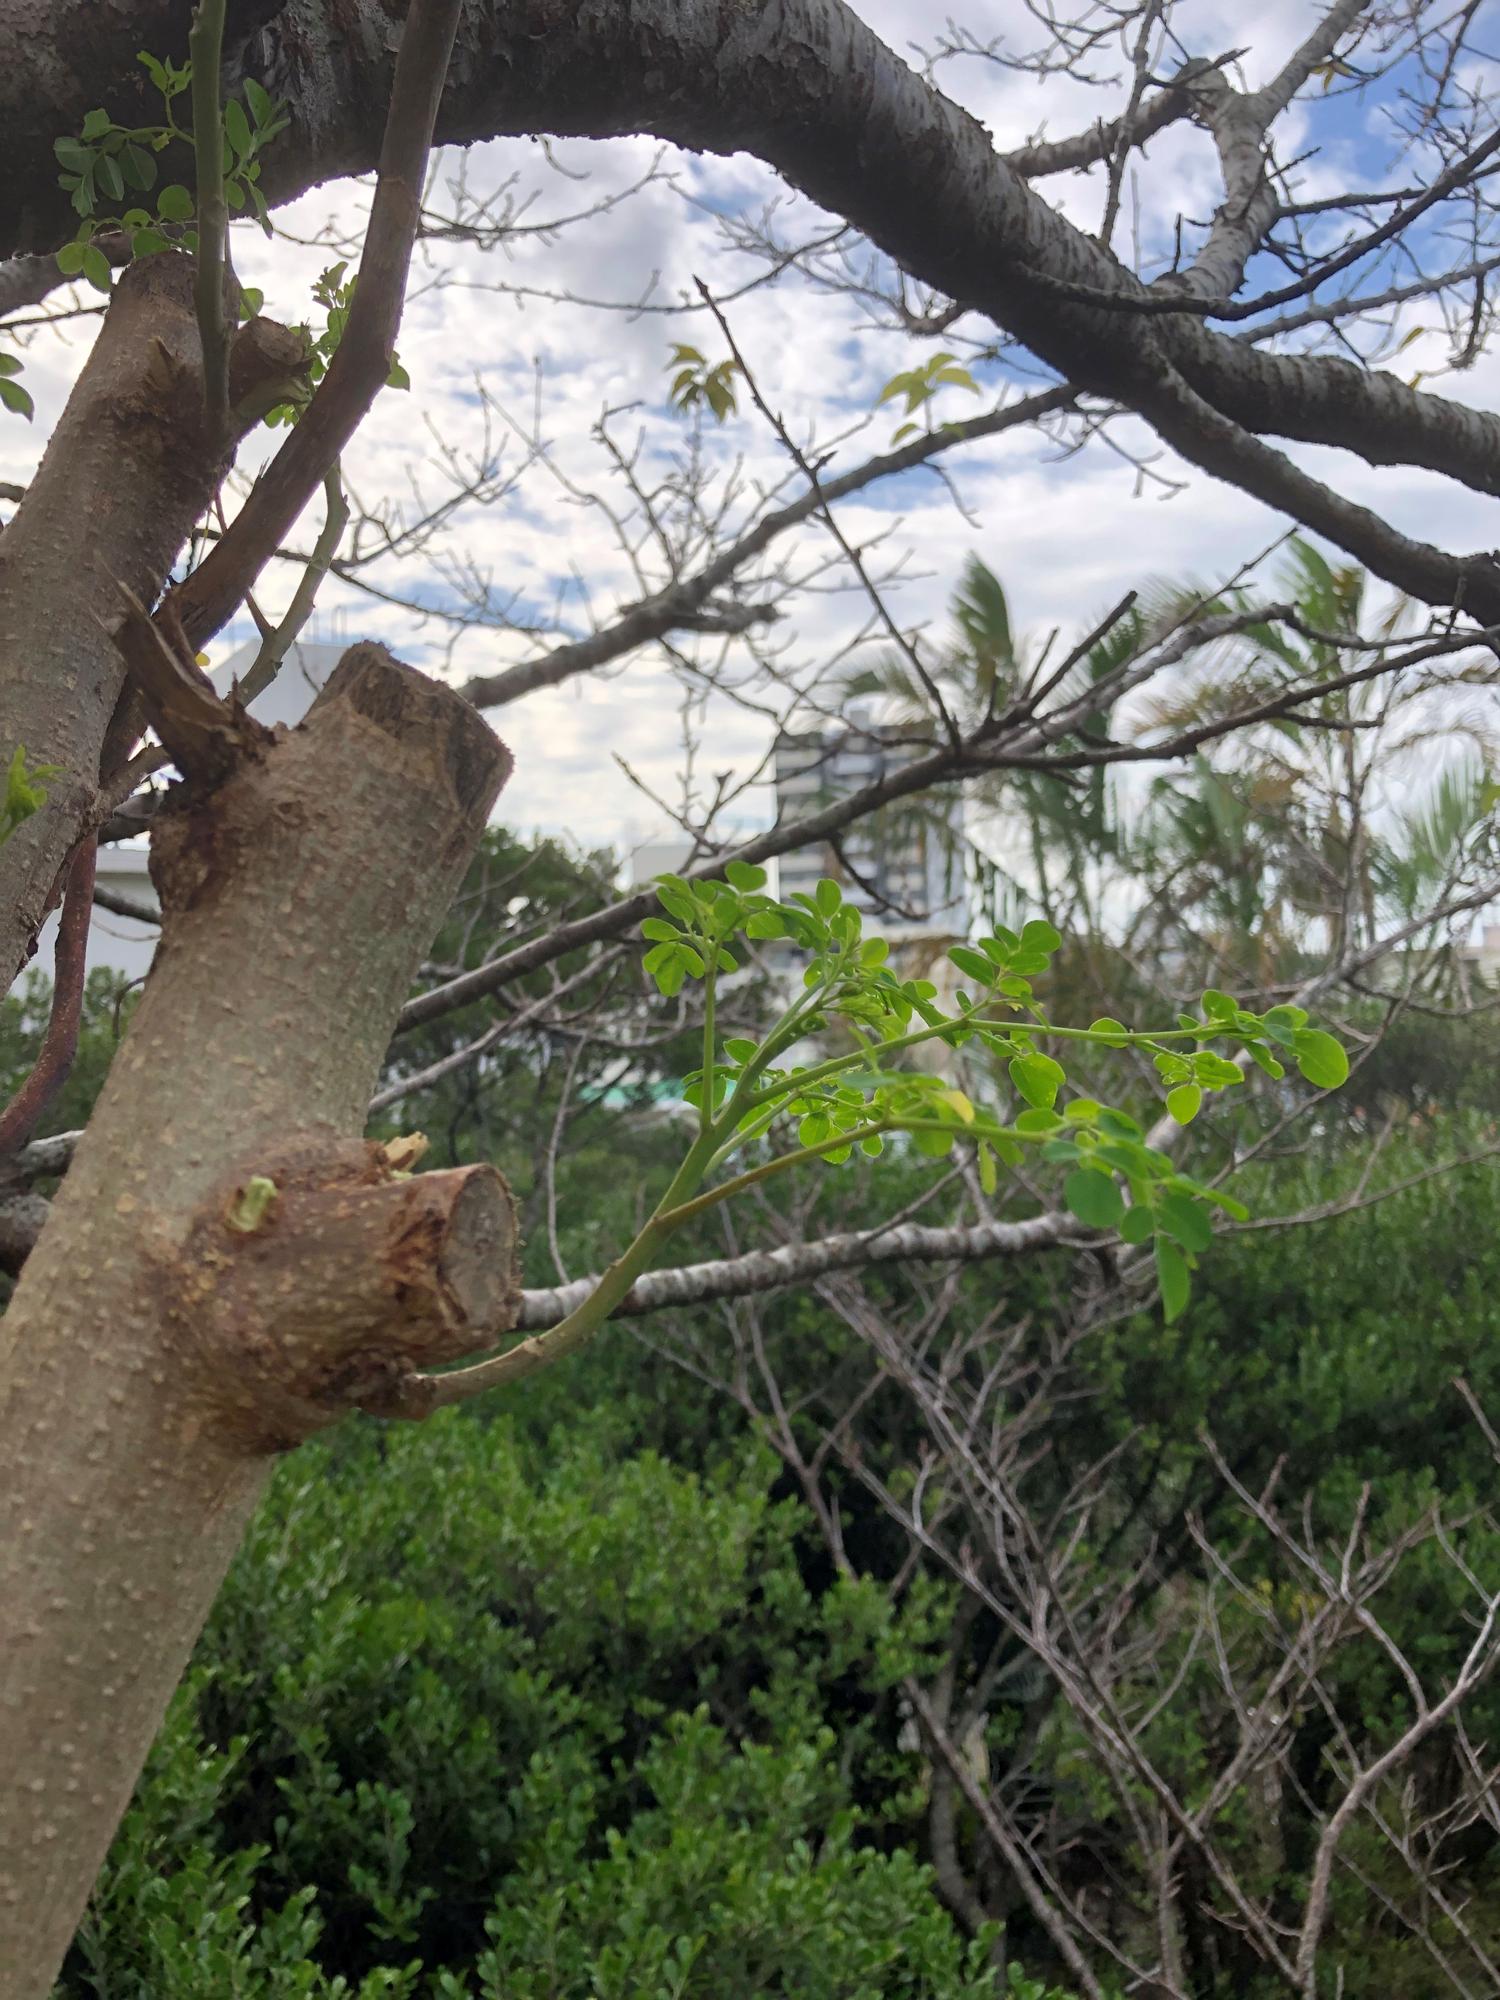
[174, 1138, 520, 1454]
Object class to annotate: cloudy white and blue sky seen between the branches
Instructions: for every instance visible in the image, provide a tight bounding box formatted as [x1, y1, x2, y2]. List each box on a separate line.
[0, 0, 1500, 868]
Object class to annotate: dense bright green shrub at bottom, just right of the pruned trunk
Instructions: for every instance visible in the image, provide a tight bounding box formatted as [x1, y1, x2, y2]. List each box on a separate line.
[60, 1412, 1072, 2000]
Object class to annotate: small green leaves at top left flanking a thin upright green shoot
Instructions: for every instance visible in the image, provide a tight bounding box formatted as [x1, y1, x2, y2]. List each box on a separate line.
[52, 50, 290, 292]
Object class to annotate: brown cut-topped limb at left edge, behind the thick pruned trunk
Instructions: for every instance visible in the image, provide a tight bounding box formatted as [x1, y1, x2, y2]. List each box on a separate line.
[0, 254, 302, 990]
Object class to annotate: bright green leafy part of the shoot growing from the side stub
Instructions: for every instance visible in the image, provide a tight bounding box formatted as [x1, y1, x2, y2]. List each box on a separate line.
[628, 860, 1348, 1320]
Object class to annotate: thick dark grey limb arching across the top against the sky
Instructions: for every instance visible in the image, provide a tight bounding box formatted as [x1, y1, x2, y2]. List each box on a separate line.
[0, 0, 1500, 624]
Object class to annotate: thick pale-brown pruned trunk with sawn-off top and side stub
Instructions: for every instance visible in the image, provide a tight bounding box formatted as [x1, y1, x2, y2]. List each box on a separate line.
[0, 646, 514, 2000]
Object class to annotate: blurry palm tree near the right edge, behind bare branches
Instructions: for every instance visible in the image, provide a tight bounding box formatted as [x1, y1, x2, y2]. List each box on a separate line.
[1120, 540, 1500, 986]
